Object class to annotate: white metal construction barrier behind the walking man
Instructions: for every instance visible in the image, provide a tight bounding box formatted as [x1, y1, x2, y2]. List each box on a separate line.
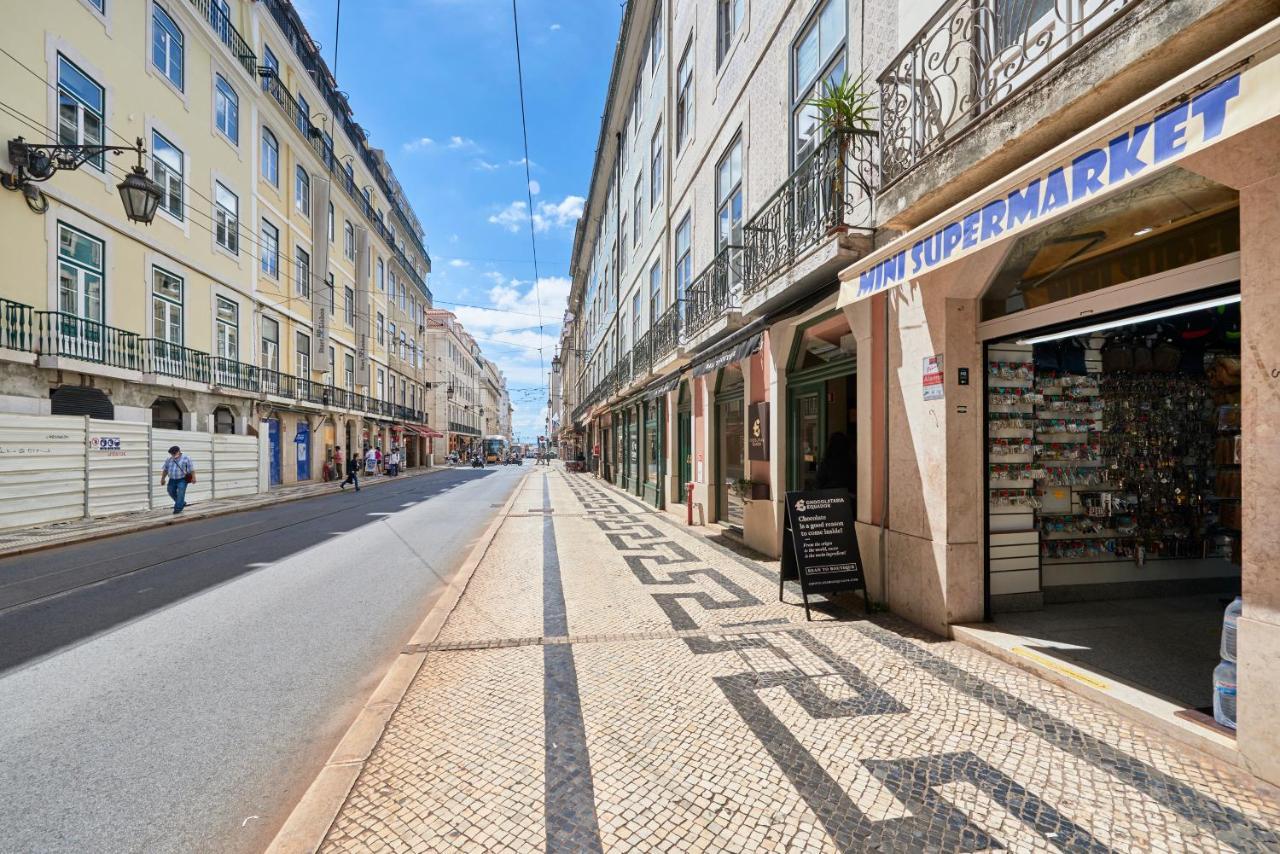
[0, 414, 266, 530]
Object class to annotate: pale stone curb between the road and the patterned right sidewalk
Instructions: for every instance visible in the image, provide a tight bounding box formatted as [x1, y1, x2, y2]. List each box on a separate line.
[266, 472, 532, 854]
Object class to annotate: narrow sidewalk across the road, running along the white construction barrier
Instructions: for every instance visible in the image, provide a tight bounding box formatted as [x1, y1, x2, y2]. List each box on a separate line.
[0, 467, 444, 557]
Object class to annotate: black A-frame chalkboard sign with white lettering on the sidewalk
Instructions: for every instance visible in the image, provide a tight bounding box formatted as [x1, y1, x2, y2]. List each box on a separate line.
[778, 489, 870, 620]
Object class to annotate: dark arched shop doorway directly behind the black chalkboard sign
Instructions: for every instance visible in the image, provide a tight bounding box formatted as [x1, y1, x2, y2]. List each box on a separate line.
[787, 312, 858, 494]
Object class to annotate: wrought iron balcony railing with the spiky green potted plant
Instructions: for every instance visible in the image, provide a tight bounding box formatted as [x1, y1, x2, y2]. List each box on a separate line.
[742, 131, 877, 294]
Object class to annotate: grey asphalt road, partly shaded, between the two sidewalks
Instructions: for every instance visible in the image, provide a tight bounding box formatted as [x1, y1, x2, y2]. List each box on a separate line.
[0, 467, 527, 853]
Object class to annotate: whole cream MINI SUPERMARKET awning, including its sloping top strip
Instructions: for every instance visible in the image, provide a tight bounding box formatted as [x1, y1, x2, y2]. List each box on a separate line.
[838, 27, 1280, 306]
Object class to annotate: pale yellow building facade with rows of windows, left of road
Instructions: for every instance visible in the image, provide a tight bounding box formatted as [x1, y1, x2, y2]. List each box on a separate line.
[0, 0, 431, 483]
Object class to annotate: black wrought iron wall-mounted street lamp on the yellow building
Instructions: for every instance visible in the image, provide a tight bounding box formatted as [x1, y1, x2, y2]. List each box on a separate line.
[0, 137, 164, 225]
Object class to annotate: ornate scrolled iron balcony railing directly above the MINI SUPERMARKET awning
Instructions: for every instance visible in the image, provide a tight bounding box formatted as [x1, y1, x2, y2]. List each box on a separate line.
[877, 0, 1138, 186]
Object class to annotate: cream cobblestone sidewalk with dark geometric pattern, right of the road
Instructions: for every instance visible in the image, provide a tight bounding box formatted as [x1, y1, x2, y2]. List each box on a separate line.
[323, 469, 1280, 851]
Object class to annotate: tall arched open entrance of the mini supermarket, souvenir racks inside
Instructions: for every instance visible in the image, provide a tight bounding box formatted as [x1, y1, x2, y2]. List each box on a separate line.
[982, 175, 1242, 721]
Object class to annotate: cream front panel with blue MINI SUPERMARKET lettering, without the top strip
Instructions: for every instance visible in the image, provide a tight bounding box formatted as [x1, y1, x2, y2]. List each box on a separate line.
[840, 45, 1280, 305]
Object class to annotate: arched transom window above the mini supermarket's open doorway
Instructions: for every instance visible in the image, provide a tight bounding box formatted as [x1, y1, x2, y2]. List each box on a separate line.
[977, 168, 1240, 320]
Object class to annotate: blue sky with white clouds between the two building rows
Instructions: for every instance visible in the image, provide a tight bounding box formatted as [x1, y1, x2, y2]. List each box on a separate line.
[294, 0, 622, 439]
